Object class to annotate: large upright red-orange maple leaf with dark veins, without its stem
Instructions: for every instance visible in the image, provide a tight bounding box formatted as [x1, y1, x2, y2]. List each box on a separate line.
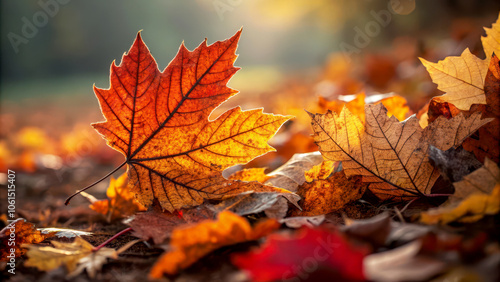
[87, 31, 290, 211]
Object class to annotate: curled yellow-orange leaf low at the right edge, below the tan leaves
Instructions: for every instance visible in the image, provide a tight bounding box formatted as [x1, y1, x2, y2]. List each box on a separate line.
[420, 159, 500, 224]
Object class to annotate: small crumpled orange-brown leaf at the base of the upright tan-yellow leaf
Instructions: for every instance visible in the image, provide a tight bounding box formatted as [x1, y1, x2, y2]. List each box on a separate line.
[292, 161, 366, 216]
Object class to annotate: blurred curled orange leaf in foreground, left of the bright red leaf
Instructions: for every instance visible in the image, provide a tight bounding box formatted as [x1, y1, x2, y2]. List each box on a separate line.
[150, 211, 280, 278]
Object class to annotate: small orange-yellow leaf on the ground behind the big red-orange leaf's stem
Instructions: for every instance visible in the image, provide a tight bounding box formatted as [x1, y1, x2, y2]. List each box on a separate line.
[90, 173, 146, 222]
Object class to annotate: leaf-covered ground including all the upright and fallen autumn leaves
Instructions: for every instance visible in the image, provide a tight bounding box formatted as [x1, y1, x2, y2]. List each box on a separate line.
[0, 12, 500, 281]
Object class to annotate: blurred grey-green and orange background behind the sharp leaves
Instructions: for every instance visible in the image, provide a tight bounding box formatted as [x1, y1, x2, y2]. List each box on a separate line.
[0, 0, 500, 207]
